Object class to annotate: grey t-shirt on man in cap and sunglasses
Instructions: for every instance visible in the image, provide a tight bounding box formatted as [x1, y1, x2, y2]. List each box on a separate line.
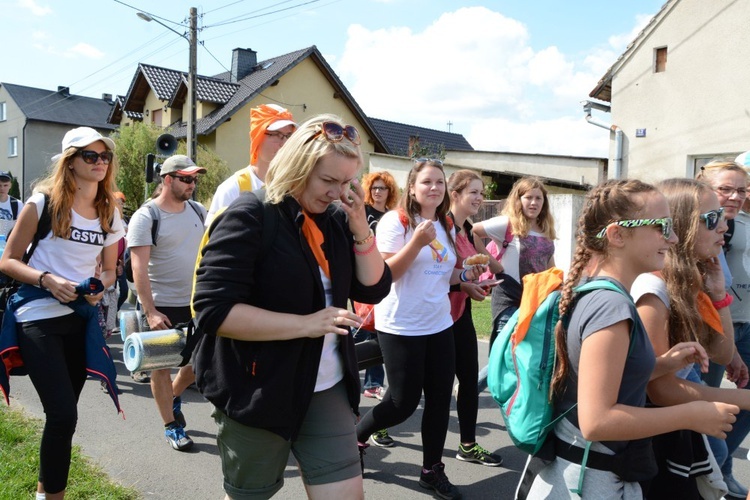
[128, 202, 206, 307]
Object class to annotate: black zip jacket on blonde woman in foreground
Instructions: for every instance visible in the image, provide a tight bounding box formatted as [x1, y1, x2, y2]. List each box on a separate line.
[193, 192, 391, 439]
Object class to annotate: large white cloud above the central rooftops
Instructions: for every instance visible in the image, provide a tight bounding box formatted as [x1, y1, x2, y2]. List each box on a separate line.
[336, 3, 618, 156]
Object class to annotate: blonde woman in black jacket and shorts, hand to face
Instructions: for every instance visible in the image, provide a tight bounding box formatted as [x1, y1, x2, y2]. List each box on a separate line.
[193, 115, 391, 499]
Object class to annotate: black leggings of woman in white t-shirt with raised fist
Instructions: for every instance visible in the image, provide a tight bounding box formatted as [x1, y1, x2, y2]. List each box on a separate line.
[357, 328, 456, 469]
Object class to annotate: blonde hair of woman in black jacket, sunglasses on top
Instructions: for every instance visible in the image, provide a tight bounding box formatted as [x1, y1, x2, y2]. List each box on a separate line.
[266, 114, 364, 204]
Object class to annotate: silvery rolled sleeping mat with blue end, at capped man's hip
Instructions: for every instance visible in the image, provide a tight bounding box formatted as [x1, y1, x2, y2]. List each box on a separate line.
[122, 329, 186, 372]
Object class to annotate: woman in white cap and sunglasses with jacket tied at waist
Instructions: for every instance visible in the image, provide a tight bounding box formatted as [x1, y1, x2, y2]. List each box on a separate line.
[0, 127, 125, 500]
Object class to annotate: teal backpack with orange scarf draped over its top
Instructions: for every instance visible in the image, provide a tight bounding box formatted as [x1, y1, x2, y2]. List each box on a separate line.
[487, 268, 635, 455]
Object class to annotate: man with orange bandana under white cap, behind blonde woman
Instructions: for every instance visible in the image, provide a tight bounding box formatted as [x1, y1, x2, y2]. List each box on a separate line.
[206, 104, 297, 227]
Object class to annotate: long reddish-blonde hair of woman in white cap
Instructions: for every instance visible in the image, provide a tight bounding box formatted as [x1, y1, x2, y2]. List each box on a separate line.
[34, 141, 118, 239]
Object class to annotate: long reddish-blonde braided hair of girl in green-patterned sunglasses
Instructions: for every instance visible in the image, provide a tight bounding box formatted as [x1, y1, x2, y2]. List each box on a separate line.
[552, 179, 657, 394]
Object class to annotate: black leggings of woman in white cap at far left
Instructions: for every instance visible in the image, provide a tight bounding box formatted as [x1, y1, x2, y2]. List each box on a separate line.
[18, 313, 86, 493]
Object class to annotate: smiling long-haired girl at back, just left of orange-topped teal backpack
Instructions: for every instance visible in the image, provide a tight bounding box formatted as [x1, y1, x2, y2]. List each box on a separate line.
[473, 177, 557, 393]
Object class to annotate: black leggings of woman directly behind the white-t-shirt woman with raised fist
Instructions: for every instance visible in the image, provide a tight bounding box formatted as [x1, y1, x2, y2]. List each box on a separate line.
[453, 298, 479, 443]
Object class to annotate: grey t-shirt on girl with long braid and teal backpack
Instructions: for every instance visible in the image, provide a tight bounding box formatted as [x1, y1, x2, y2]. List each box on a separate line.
[555, 279, 656, 452]
